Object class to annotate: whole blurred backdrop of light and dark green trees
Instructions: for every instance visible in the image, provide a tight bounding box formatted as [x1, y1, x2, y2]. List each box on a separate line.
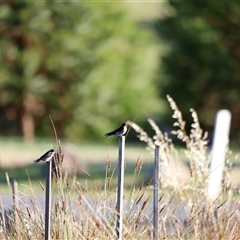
[0, 0, 240, 143]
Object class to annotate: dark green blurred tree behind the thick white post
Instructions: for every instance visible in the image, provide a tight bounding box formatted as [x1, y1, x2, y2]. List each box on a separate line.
[156, 0, 240, 138]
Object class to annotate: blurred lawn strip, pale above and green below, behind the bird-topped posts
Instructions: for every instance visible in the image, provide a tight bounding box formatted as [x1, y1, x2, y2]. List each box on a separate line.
[0, 138, 156, 191]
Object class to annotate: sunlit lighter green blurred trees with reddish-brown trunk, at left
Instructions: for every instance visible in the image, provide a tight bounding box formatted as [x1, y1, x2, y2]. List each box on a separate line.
[0, 1, 159, 139]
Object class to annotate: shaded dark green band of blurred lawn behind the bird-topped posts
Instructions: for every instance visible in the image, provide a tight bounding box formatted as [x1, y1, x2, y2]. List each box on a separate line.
[0, 158, 152, 191]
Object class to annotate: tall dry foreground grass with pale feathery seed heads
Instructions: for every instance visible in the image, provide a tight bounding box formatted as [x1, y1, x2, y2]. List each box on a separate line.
[0, 96, 240, 240]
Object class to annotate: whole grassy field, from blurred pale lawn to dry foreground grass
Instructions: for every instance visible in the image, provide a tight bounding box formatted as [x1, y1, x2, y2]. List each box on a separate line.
[0, 98, 240, 240]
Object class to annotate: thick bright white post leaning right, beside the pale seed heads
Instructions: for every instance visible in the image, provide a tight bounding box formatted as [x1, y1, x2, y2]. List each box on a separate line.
[208, 110, 231, 200]
